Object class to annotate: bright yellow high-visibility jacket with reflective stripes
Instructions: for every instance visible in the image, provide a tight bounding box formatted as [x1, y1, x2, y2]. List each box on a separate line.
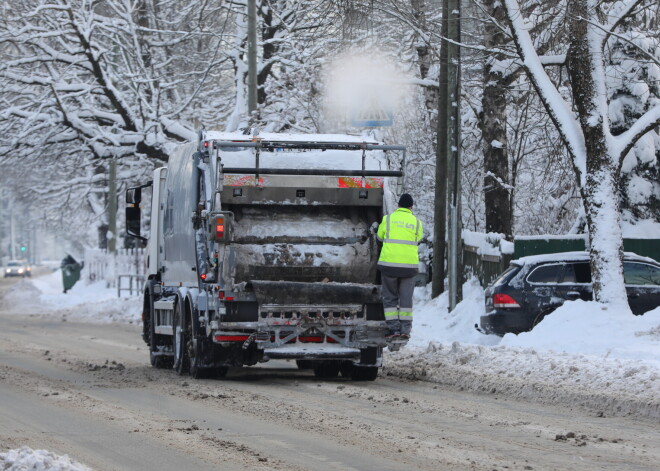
[377, 208, 424, 270]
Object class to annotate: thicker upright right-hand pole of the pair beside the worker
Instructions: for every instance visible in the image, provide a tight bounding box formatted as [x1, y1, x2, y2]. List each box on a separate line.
[447, 0, 463, 311]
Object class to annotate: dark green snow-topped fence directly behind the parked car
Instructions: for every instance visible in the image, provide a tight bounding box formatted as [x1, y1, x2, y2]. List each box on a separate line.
[513, 235, 660, 262]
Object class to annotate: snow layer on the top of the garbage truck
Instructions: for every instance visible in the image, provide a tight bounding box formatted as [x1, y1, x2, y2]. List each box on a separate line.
[205, 132, 389, 170]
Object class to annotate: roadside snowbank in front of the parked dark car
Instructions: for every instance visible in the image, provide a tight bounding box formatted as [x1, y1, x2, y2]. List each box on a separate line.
[385, 279, 660, 418]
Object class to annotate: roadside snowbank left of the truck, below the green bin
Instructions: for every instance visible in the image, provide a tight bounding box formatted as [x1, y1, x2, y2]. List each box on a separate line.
[1, 270, 142, 324]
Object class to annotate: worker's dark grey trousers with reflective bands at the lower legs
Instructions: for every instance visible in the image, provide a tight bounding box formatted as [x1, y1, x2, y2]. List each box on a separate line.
[381, 272, 415, 335]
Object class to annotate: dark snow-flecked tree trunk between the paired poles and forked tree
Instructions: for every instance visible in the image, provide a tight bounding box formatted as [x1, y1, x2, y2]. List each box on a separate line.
[479, 0, 513, 239]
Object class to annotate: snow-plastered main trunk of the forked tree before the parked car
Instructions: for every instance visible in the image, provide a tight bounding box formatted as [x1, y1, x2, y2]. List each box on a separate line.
[567, 0, 627, 305]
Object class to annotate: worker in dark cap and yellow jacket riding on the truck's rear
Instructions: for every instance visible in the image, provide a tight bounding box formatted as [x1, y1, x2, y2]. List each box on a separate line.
[377, 193, 424, 340]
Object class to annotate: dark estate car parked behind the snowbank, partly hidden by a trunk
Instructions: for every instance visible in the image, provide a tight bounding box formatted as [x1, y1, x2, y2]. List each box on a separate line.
[480, 252, 660, 335]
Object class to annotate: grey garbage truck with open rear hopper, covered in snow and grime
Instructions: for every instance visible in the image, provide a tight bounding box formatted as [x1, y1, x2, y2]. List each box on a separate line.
[126, 131, 405, 381]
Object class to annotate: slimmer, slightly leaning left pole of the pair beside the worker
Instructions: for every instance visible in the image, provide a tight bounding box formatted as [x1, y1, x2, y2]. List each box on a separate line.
[431, 0, 449, 298]
